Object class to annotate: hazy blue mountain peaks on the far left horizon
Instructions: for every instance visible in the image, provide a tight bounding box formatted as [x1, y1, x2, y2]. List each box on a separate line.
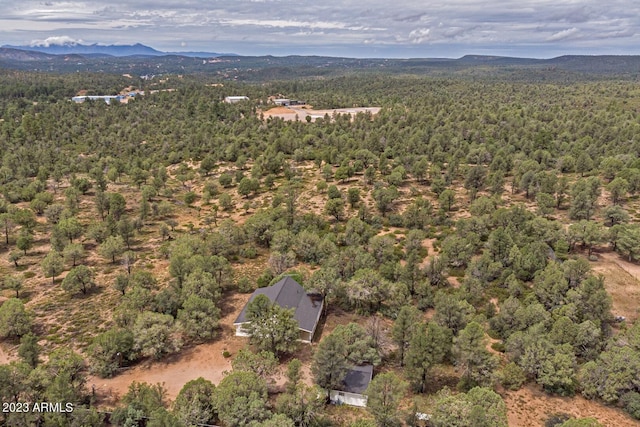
[2, 43, 234, 58]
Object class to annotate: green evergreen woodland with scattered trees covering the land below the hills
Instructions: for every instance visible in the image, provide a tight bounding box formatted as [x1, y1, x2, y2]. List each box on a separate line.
[0, 67, 640, 427]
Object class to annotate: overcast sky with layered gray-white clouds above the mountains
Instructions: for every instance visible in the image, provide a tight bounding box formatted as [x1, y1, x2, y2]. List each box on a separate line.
[0, 0, 640, 58]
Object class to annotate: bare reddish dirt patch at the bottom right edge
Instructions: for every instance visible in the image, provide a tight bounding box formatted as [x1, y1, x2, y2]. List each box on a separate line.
[503, 385, 640, 427]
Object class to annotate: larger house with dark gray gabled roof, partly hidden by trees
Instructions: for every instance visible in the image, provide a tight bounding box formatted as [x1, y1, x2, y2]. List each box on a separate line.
[233, 276, 324, 342]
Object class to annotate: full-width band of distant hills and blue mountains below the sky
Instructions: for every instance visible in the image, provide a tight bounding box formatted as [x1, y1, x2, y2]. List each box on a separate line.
[0, 43, 640, 81]
